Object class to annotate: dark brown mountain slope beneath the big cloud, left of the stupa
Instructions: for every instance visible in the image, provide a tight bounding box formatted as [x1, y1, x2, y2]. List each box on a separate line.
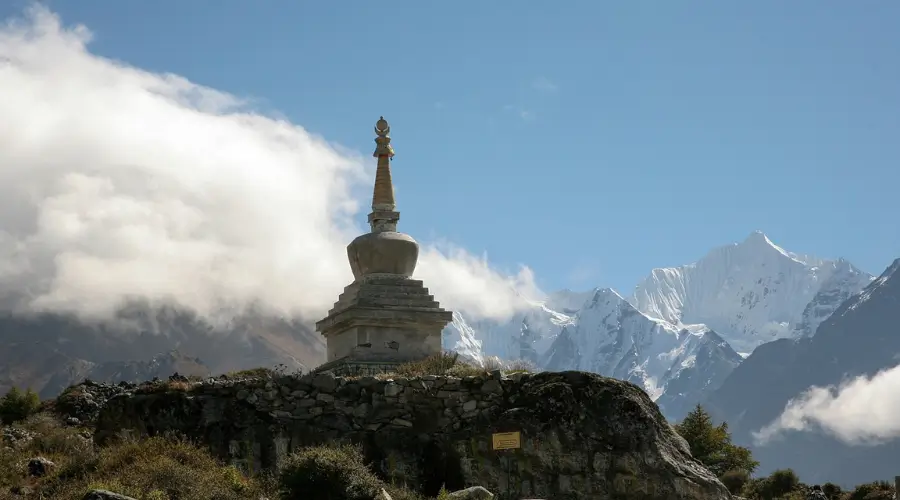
[0, 306, 324, 397]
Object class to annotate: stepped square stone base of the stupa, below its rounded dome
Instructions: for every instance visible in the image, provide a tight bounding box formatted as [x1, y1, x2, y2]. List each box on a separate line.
[316, 275, 453, 371]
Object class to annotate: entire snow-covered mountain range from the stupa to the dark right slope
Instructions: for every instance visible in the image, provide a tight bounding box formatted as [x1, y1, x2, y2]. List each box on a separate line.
[444, 231, 873, 418]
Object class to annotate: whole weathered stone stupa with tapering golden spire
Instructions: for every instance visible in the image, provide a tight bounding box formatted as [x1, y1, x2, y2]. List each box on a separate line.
[316, 117, 453, 375]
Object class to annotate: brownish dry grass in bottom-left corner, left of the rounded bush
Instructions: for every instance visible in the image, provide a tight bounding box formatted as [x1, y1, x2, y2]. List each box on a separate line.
[0, 415, 276, 500]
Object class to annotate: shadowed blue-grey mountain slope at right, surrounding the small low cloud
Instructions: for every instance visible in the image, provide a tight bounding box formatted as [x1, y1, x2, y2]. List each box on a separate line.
[707, 259, 900, 485]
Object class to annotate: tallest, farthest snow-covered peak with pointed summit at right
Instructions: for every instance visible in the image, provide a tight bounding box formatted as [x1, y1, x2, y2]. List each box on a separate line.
[632, 231, 873, 353]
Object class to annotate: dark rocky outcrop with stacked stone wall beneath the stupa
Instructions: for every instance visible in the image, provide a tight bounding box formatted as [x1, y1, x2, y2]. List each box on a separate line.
[87, 372, 730, 500]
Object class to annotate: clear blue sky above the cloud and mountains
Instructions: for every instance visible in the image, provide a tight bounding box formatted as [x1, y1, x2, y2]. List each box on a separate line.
[8, 0, 900, 292]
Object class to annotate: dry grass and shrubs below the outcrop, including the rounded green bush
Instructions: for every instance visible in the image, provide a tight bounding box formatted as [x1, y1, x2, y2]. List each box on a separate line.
[0, 414, 450, 500]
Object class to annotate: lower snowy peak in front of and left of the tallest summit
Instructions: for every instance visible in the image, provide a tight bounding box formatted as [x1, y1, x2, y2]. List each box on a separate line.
[541, 288, 741, 418]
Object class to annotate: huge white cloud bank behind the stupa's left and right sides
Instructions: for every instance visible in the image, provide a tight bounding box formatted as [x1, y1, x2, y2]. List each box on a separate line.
[0, 7, 538, 319]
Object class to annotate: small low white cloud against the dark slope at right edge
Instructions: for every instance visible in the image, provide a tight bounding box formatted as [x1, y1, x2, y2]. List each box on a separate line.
[754, 366, 900, 445]
